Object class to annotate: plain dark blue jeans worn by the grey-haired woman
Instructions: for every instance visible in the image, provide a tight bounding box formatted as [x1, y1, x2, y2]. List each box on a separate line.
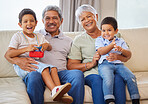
[85, 74, 126, 104]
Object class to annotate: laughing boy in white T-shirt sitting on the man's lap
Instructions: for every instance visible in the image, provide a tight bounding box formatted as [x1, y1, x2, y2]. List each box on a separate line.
[4, 9, 73, 103]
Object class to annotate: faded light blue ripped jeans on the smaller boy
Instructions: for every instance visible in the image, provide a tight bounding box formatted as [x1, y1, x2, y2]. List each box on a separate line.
[98, 60, 140, 99]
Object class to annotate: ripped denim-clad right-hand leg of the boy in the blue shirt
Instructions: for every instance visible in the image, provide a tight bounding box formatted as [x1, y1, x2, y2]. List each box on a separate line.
[117, 64, 140, 104]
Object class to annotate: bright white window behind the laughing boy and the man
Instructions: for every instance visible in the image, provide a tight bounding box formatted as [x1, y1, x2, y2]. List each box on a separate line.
[0, 0, 59, 30]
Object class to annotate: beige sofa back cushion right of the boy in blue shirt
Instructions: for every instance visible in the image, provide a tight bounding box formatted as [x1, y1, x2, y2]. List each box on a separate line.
[119, 28, 148, 72]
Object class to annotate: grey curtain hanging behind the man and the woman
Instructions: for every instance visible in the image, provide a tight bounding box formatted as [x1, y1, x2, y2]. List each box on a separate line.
[59, 0, 101, 32]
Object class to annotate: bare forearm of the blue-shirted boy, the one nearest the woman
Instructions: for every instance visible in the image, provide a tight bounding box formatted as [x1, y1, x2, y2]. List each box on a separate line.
[97, 39, 115, 55]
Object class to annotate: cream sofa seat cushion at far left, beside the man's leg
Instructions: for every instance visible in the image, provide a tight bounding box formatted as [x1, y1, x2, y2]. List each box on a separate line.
[0, 77, 31, 104]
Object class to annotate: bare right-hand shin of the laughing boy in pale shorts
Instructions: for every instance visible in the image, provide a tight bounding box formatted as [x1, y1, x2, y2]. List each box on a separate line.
[50, 67, 61, 86]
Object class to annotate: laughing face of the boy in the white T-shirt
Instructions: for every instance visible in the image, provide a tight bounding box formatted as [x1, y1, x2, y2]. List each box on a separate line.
[18, 14, 37, 34]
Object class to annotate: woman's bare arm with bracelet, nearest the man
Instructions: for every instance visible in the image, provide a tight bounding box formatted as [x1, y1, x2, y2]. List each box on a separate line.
[67, 52, 100, 72]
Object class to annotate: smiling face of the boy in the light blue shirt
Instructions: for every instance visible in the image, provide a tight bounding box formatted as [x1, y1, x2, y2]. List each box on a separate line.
[102, 24, 118, 41]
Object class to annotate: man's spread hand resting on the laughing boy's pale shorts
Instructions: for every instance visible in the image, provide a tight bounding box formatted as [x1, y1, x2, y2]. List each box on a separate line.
[16, 57, 38, 72]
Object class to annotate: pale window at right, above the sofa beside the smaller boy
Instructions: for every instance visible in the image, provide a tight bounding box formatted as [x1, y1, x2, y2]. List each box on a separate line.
[117, 0, 148, 29]
